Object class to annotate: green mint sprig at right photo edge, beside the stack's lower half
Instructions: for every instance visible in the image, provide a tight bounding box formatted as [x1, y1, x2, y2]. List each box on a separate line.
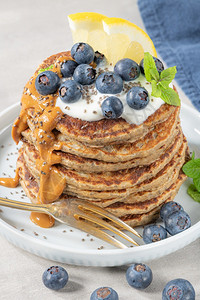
[182, 152, 200, 202]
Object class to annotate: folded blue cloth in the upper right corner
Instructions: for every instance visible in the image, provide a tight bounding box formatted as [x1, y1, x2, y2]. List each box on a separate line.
[138, 0, 200, 111]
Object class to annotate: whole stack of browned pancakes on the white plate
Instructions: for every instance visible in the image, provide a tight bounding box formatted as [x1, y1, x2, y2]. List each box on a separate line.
[14, 51, 188, 226]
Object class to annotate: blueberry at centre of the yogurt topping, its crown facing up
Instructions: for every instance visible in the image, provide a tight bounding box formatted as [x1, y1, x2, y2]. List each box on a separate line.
[96, 72, 123, 94]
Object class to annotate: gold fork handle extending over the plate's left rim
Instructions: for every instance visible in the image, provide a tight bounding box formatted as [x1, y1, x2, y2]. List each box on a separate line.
[0, 197, 47, 213]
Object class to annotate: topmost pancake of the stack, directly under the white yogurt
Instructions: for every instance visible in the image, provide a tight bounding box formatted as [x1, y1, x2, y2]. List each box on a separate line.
[56, 97, 179, 146]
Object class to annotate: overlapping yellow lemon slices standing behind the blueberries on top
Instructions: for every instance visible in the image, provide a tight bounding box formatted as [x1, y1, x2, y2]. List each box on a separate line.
[68, 12, 157, 65]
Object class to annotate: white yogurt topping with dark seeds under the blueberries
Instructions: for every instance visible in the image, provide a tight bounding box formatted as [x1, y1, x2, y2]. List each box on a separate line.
[56, 65, 164, 125]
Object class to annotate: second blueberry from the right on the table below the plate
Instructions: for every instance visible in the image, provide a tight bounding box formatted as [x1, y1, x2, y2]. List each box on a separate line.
[126, 263, 153, 289]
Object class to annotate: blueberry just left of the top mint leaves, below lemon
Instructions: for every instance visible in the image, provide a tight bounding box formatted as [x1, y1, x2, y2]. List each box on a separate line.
[114, 58, 140, 81]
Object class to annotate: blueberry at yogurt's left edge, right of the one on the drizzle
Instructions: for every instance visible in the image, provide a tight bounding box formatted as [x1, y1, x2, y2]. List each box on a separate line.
[59, 80, 82, 103]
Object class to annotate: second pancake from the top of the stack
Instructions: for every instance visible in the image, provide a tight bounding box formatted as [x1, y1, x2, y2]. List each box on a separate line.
[22, 111, 179, 162]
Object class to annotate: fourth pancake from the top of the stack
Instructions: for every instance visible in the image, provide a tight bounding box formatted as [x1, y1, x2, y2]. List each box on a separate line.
[21, 132, 187, 191]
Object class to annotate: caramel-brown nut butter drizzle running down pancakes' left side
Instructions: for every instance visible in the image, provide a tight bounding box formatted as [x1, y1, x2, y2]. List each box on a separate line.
[0, 54, 70, 227]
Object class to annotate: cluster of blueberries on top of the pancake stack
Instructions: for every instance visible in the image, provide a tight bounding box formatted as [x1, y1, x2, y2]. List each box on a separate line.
[35, 43, 164, 119]
